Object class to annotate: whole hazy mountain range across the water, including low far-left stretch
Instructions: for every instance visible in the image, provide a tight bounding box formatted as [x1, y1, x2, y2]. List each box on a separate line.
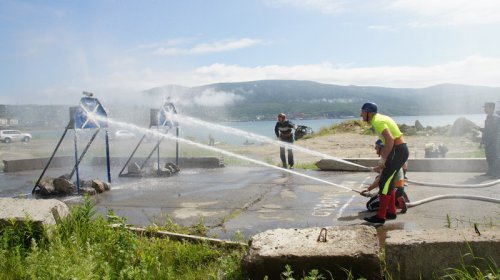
[0, 80, 500, 129]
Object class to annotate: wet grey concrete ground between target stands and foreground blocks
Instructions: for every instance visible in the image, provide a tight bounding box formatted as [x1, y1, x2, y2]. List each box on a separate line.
[0, 167, 500, 238]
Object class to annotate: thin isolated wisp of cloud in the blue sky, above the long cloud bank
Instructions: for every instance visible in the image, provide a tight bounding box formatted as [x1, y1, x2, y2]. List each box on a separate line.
[154, 38, 261, 55]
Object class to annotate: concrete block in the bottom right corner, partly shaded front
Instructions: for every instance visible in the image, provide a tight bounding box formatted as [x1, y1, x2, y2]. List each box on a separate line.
[385, 227, 500, 279]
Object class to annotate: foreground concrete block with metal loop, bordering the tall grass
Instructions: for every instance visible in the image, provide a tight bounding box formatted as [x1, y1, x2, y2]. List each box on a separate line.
[243, 226, 381, 279]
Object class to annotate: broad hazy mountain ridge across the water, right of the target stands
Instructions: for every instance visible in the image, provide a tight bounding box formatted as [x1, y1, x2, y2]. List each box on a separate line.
[144, 80, 500, 121]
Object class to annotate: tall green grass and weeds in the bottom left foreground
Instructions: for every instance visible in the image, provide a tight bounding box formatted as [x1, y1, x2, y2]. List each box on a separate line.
[0, 199, 246, 279]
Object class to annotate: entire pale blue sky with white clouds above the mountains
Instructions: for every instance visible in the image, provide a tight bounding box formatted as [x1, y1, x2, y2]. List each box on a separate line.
[0, 0, 500, 104]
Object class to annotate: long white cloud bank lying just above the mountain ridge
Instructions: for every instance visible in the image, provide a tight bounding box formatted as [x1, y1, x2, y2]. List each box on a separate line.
[195, 55, 500, 87]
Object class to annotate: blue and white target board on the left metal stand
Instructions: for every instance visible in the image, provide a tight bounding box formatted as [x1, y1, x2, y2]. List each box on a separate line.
[74, 96, 108, 129]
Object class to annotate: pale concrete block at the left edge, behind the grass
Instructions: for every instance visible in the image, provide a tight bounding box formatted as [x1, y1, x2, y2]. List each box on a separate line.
[0, 198, 69, 229]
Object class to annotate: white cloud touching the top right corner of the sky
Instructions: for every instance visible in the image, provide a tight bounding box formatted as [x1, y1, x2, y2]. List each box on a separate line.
[387, 0, 500, 27]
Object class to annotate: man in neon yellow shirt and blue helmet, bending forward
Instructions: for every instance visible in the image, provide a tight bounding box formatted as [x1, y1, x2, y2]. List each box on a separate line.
[360, 102, 410, 224]
